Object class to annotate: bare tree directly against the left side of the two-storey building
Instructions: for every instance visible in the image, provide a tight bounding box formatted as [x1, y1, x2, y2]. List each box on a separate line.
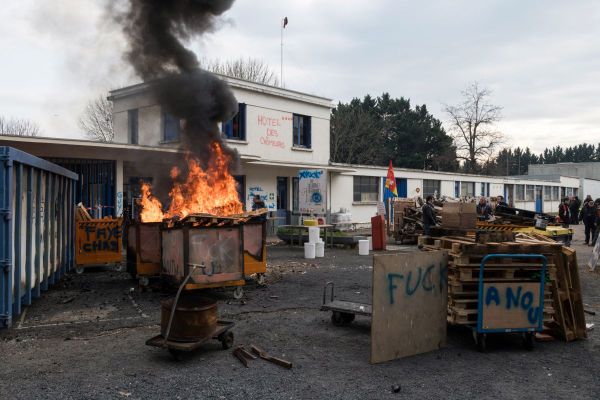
[79, 96, 115, 142]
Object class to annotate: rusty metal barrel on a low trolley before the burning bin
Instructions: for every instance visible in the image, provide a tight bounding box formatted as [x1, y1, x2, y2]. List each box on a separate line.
[160, 292, 218, 342]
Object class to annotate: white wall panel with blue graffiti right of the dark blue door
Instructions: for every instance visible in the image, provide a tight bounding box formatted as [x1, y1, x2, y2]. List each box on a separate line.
[298, 169, 327, 214]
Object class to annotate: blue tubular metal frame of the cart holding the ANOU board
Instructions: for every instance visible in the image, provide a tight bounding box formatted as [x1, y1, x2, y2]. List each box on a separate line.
[470, 254, 548, 352]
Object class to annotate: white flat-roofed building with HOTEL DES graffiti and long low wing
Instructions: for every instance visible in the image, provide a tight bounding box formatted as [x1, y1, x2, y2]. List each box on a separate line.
[0, 77, 581, 223]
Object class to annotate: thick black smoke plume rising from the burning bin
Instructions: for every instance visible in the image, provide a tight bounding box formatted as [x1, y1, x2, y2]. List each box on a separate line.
[117, 0, 238, 198]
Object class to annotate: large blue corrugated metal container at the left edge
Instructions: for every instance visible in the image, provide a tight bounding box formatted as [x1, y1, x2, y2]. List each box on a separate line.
[0, 147, 77, 328]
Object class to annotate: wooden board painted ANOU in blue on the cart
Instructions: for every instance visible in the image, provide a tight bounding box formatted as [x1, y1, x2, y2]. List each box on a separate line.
[480, 282, 541, 329]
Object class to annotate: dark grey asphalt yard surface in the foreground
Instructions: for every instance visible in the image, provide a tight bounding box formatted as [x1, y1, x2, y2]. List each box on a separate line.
[0, 227, 600, 399]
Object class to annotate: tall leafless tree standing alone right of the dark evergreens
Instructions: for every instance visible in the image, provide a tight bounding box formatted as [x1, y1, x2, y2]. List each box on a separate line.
[444, 82, 504, 172]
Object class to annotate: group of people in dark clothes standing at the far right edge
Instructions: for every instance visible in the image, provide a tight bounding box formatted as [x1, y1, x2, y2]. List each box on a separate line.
[558, 195, 600, 246]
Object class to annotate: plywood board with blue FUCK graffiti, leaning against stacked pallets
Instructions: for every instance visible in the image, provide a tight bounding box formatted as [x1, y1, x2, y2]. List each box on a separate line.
[371, 251, 448, 363]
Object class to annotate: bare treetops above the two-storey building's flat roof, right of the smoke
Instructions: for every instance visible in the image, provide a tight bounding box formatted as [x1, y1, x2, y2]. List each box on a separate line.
[201, 58, 279, 86]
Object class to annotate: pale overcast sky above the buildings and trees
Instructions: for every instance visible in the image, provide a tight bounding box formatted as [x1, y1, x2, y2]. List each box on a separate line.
[0, 0, 600, 151]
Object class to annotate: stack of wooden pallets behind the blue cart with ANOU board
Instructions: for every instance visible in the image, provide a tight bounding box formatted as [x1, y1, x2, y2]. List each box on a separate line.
[420, 234, 586, 341]
